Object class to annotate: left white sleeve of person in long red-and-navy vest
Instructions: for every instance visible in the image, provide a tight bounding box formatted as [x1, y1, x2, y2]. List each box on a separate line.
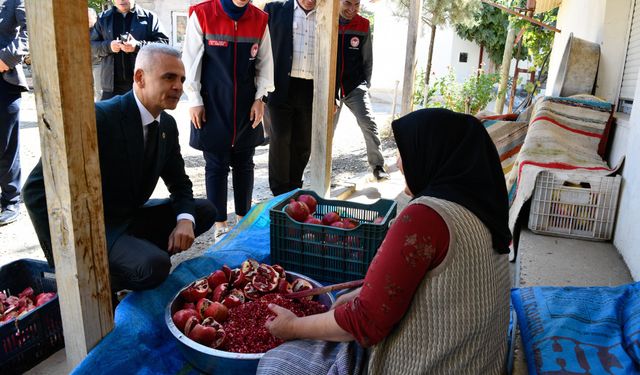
[182, 12, 204, 107]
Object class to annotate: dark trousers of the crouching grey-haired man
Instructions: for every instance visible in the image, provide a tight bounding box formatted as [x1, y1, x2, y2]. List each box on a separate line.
[109, 199, 215, 292]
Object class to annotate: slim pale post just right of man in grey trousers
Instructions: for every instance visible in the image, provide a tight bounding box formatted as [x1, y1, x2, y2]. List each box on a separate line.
[400, 0, 426, 116]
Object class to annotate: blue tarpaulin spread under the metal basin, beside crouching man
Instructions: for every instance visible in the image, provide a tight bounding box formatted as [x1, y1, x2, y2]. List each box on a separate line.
[73, 197, 280, 375]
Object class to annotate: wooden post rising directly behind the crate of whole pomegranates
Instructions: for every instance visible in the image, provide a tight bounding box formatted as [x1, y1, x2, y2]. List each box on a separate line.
[310, 0, 340, 197]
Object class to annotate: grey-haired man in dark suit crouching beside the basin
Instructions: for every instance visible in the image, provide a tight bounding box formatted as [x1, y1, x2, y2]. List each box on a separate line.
[23, 44, 215, 290]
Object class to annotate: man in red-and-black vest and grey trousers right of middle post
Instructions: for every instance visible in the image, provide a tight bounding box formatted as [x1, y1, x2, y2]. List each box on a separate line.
[334, 0, 389, 181]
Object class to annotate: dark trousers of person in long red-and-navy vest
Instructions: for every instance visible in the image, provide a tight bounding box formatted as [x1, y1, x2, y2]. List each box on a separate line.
[203, 147, 256, 222]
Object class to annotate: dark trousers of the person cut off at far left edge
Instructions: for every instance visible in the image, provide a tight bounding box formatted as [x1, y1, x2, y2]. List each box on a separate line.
[0, 76, 20, 207]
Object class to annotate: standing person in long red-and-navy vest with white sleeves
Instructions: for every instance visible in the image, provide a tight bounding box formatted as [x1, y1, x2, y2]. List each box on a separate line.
[182, 0, 273, 238]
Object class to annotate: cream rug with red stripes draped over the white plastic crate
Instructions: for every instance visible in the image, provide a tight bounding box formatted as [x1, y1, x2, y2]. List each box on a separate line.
[507, 95, 617, 254]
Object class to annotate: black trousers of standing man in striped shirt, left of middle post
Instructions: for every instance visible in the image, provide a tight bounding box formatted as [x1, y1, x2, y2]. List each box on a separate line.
[267, 78, 313, 196]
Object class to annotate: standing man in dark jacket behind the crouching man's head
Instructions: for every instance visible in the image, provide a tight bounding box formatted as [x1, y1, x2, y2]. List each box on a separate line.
[91, 0, 169, 100]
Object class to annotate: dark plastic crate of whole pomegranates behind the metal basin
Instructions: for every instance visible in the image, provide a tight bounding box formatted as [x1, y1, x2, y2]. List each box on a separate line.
[269, 190, 397, 282]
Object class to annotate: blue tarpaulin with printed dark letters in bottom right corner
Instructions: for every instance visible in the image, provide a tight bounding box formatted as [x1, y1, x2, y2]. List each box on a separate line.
[511, 283, 640, 375]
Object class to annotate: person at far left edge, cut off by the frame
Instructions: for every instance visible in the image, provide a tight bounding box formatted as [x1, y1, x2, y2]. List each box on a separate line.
[0, 0, 29, 226]
